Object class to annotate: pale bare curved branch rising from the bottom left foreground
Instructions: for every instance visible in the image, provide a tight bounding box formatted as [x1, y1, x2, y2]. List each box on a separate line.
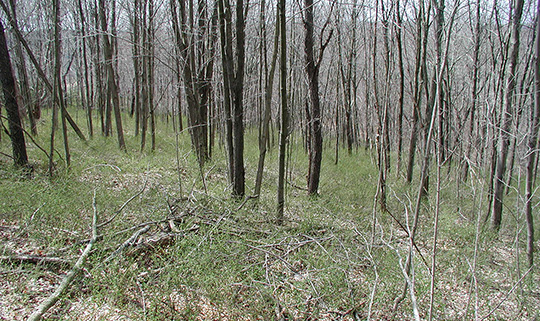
[28, 191, 97, 321]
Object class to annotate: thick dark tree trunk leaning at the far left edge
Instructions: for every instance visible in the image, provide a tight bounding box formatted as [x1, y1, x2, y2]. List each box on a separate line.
[0, 21, 28, 166]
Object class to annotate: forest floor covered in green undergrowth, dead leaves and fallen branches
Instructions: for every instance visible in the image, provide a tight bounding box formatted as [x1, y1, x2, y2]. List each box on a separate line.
[0, 110, 540, 320]
